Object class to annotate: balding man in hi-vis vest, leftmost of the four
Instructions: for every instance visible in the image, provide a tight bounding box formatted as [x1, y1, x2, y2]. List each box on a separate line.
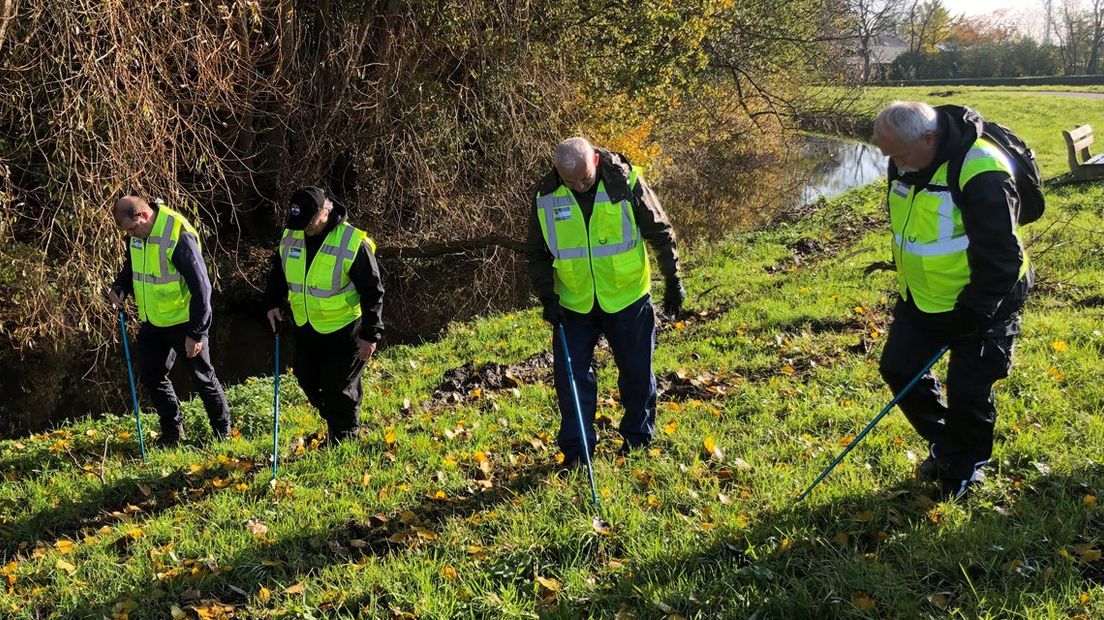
[107, 195, 230, 447]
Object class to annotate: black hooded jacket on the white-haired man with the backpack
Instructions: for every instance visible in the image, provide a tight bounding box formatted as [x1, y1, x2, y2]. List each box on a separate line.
[889, 106, 1032, 325]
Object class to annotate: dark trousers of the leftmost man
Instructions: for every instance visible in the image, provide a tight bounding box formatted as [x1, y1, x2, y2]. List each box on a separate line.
[137, 323, 230, 439]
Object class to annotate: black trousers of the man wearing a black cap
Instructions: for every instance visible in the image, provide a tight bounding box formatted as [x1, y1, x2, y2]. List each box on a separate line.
[291, 320, 364, 439]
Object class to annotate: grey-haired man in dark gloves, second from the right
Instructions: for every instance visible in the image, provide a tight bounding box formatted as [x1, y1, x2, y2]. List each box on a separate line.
[527, 137, 686, 468]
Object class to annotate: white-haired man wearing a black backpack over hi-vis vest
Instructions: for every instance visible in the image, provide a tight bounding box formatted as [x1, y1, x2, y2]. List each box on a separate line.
[873, 101, 1042, 500]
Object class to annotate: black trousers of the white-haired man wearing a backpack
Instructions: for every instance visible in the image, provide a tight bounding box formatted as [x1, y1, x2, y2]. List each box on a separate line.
[880, 301, 1022, 481]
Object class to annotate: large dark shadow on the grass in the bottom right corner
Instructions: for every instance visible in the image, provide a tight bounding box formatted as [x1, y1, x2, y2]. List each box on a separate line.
[542, 466, 1104, 618]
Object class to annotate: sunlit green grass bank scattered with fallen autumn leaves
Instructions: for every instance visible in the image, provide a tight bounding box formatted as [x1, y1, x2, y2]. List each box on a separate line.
[0, 90, 1104, 618]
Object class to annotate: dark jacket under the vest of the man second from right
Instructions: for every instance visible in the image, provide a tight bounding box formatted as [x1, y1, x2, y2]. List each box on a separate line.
[526, 149, 679, 303]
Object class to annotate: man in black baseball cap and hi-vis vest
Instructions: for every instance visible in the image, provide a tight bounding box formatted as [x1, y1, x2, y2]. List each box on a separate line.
[265, 186, 383, 442]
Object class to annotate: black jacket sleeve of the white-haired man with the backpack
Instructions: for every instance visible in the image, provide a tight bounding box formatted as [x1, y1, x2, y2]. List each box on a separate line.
[955, 171, 1023, 320]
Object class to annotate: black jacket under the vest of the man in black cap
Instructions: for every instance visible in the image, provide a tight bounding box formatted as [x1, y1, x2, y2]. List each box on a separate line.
[264, 205, 383, 342]
